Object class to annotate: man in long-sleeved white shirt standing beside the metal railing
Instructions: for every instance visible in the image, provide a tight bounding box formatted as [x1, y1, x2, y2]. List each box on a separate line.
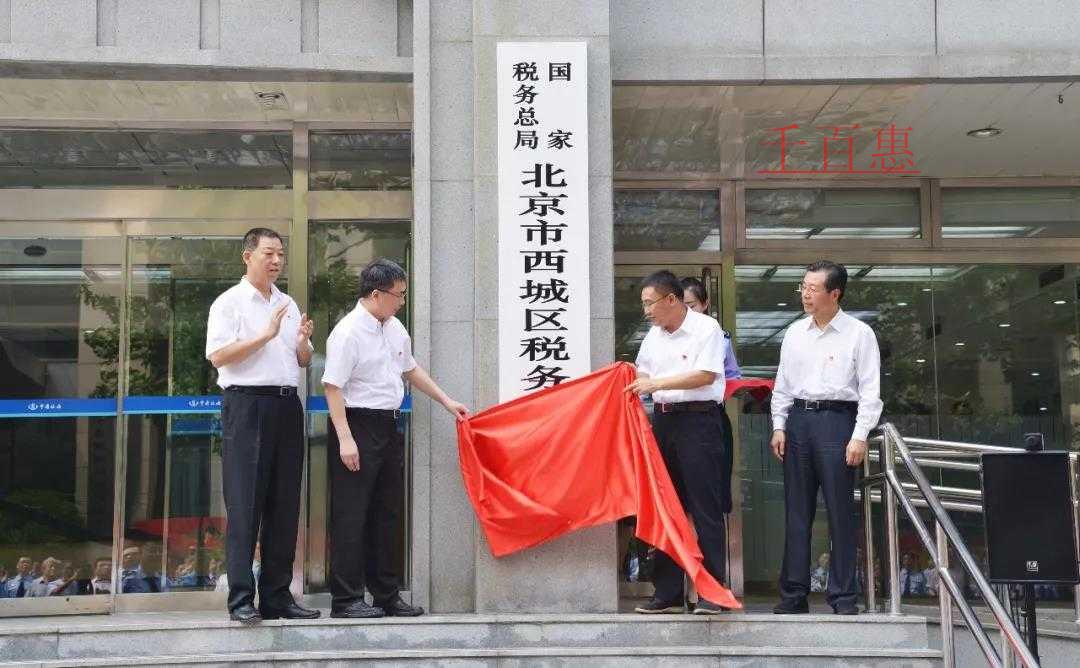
[771, 260, 881, 615]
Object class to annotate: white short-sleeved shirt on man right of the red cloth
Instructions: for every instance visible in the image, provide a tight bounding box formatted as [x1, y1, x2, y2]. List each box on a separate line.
[637, 309, 727, 404]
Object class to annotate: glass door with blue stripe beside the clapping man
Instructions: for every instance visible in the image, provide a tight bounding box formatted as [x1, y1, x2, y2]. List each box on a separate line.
[117, 222, 287, 610]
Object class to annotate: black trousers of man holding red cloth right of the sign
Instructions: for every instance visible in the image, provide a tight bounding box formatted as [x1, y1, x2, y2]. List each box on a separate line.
[652, 404, 731, 603]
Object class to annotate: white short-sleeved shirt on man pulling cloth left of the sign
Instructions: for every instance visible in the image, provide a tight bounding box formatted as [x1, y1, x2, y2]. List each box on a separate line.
[323, 303, 416, 409]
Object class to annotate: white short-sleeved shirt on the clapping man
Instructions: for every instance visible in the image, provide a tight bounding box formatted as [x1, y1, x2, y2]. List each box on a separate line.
[206, 278, 310, 387]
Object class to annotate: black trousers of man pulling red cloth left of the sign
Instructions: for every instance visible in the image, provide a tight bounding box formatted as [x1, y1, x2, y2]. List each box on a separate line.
[326, 408, 405, 610]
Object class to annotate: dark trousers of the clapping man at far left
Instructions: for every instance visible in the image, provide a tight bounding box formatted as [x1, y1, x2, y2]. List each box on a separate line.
[221, 387, 303, 611]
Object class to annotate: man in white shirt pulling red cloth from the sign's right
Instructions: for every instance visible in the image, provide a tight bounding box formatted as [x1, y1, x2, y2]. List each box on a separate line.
[626, 271, 731, 614]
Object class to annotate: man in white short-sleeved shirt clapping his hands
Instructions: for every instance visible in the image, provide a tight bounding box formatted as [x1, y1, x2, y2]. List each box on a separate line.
[206, 228, 319, 624]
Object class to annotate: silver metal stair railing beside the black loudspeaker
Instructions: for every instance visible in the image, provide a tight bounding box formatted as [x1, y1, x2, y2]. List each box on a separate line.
[856, 423, 1080, 668]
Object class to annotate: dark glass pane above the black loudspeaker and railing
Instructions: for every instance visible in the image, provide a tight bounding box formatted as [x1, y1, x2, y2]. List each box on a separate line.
[934, 264, 1080, 449]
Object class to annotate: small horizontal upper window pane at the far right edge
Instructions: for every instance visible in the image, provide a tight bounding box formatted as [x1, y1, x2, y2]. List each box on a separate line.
[942, 188, 1080, 238]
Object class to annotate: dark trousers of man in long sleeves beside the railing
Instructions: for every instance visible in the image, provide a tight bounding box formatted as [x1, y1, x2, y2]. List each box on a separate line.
[780, 404, 859, 608]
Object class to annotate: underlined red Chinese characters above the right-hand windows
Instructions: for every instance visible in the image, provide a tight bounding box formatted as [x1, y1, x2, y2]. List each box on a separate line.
[757, 123, 919, 176]
